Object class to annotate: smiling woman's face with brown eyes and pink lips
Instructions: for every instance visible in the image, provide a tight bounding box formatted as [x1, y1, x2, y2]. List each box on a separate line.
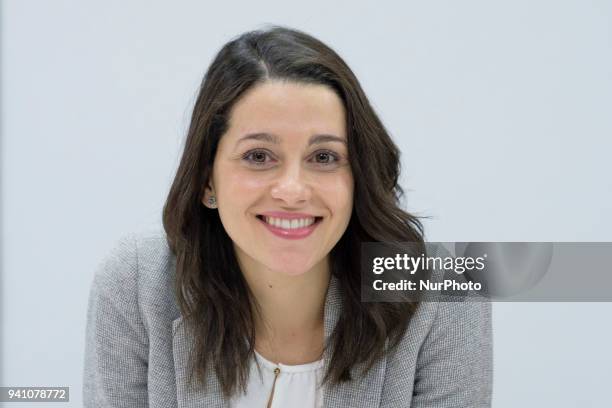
[203, 82, 354, 276]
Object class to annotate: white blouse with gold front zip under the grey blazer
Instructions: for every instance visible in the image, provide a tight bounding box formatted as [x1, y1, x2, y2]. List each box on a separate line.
[230, 351, 323, 408]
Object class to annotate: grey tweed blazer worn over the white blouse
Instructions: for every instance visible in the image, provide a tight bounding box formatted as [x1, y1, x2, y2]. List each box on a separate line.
[83, 230, 493, 408]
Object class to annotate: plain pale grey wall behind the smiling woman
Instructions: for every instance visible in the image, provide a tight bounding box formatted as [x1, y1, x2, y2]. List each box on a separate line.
[1, 0, 612, 408]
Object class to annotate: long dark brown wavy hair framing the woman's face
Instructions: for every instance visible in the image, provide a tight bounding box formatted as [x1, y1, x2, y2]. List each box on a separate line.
[163, 25, 424, 397]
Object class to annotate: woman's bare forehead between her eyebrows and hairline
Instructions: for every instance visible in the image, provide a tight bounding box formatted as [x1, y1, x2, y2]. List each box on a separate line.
[228, 81, 346, 138]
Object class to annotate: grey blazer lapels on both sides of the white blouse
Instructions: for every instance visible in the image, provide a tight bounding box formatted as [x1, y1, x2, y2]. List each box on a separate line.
[172, 275, 386, 408]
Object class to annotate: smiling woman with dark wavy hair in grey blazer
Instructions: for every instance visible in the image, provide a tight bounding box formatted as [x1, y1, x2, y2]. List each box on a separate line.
[84, 26, 492, 408]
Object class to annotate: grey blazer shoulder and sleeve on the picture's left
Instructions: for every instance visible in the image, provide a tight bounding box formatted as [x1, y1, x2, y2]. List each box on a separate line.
[83, 231, 174, 407]
